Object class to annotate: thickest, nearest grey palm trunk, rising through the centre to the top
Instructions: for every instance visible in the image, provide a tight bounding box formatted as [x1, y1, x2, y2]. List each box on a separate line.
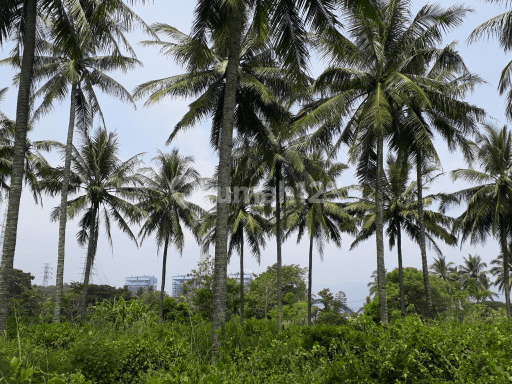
[212, 9, 243, 362]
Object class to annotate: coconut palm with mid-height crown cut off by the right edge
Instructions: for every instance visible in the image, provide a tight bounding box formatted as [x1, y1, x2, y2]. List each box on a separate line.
[443, 124, 512, 317]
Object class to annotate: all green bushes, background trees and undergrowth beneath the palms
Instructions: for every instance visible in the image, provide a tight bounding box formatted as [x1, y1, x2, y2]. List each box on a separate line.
[0, 265, 512, 384]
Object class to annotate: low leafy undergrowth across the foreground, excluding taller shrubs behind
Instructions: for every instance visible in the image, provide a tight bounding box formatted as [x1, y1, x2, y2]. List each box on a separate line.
[0, 316, 512, 384]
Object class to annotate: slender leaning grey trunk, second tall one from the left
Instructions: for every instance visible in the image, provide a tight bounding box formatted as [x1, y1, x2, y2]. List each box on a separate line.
[53, 83, 76, 323]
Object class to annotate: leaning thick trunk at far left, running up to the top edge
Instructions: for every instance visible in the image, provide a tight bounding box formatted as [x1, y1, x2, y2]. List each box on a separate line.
[0, 0, 37, 332]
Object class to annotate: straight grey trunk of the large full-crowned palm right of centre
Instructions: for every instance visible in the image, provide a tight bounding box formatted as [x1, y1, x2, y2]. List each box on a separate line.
[375, 133, 388, 324]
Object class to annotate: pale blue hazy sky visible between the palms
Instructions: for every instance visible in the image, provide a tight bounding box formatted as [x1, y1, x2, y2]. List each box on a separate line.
[0, 0, 512, 308]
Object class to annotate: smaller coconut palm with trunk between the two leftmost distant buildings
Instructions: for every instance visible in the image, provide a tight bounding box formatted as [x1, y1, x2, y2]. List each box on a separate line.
[139, 149, 203, 321]
